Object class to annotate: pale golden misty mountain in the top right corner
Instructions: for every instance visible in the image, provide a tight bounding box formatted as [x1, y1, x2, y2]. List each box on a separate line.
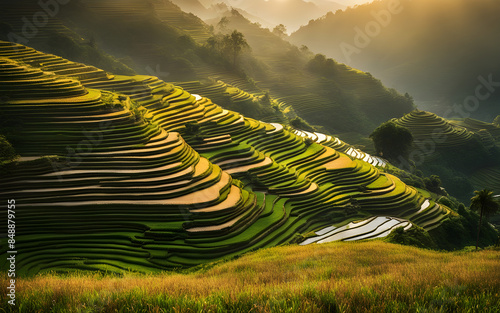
[290, 0, 500, 121]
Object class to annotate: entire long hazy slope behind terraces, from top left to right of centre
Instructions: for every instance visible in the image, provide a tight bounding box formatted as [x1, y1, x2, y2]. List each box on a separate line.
[0, 0, 413, 135]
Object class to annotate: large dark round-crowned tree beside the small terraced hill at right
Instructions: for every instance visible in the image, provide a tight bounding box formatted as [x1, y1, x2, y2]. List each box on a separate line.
[370, 121, 413, 161]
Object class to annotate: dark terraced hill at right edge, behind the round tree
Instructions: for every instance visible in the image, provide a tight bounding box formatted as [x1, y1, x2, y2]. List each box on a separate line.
[388, 111, 500, 203]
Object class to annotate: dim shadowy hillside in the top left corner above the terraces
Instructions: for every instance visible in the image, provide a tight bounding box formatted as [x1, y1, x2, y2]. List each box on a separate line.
[0, 0, 209, 79]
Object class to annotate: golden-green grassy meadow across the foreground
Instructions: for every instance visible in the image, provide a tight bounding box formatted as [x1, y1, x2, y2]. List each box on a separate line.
[0, 241, 500, 312]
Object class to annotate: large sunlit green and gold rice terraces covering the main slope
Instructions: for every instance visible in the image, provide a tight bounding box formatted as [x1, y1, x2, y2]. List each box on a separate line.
[0, 42, 452, 274]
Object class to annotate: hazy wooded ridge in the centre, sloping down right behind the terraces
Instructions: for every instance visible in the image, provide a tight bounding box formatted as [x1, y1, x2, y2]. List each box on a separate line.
[203, 11, 413, 135]
